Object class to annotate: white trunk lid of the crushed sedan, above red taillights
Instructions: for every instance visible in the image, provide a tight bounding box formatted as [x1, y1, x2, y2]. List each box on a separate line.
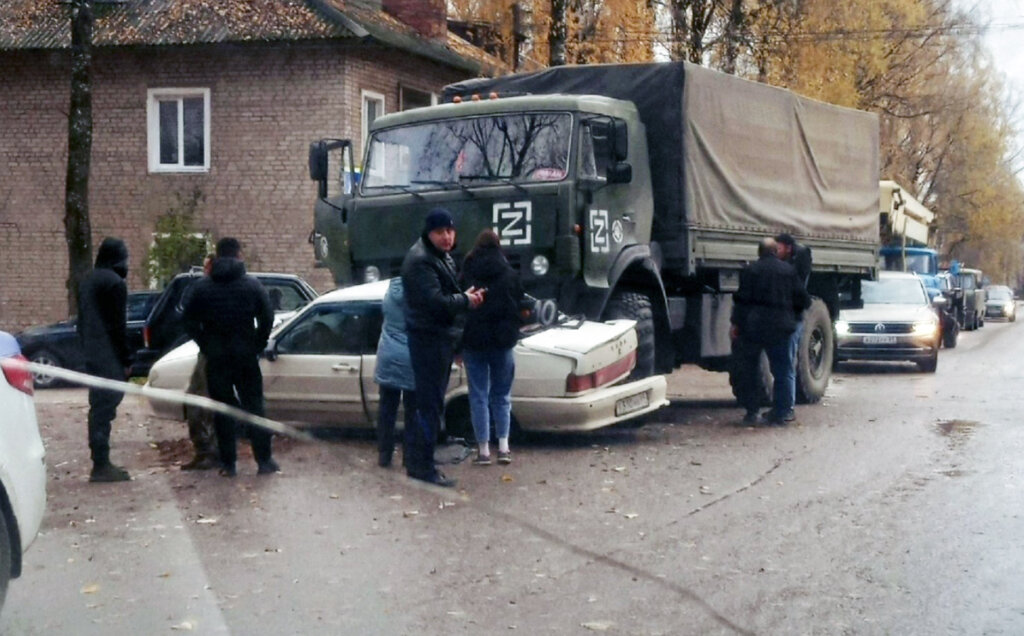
[519, 320, 637, 375]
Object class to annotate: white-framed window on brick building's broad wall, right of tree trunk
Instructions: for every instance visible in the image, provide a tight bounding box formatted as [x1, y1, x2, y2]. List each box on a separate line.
[146, 88, 210, 172]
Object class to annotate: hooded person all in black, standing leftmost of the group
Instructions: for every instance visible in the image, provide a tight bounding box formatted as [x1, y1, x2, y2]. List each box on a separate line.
[77, 237, 131, 481]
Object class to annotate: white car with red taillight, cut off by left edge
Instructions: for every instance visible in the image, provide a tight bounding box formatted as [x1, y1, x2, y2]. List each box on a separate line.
[0, 331, 46, 608]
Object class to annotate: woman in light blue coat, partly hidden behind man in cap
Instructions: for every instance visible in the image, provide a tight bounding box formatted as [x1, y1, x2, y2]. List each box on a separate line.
[374, 277, 416, 467]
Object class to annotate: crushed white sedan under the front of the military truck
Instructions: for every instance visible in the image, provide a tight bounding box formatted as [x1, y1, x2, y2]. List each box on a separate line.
[147, 281, 669, 437]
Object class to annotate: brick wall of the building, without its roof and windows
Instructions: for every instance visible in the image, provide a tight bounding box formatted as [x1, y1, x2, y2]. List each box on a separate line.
[0, 43, 466, 331]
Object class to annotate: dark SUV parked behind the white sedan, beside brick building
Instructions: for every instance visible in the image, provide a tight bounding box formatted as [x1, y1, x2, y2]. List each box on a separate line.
[131, 267, 317, 376]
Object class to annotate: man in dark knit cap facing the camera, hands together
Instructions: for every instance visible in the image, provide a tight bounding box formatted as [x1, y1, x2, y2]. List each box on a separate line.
[401, 208, 483, 487]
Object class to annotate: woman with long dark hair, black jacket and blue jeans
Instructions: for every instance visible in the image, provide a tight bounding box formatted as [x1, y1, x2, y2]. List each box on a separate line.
[462, 229, 524, 466]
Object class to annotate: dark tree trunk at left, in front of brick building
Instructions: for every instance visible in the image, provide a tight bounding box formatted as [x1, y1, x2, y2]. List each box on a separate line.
[65, 0, 93, 314]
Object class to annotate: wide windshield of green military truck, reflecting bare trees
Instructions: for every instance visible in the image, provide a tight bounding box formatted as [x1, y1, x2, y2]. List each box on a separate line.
[361, 113, 572, 194]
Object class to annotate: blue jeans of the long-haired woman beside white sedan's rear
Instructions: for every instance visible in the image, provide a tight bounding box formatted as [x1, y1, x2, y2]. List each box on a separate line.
[462, 349, 515, 443]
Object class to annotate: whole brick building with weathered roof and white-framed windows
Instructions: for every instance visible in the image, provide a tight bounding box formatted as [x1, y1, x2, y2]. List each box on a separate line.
[0, 0, 502, 331]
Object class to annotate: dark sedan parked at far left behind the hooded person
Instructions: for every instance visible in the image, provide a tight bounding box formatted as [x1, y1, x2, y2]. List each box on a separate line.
[16, 291, 160, 388]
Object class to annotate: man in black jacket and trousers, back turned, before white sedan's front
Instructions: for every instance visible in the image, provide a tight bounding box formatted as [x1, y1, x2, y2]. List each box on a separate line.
[183, 237, 280, 477]
